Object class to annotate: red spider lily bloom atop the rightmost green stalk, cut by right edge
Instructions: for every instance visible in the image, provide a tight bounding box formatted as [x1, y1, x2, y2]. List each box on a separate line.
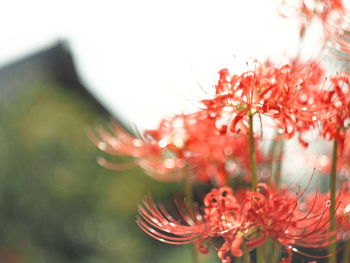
[319, 73, 350, 149]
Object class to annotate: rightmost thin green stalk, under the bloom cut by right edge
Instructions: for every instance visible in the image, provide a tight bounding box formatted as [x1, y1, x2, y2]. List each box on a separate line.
[328, 140, 338, 263]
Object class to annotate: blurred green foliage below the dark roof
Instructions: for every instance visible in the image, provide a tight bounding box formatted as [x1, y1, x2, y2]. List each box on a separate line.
[0, 63, 220, 263]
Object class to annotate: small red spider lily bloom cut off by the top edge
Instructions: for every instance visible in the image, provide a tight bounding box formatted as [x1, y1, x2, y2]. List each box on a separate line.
[281, 0, 345, 38]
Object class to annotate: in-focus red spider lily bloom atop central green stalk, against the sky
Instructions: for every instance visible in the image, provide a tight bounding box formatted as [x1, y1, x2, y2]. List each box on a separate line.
[202, 60, 323, 145]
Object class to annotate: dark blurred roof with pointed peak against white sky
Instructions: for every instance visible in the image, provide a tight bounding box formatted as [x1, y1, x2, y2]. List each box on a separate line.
[0, 41, 109, 114]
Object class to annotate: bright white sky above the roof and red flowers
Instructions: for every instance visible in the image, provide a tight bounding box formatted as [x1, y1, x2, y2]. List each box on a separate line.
[0, 0, 330, 128]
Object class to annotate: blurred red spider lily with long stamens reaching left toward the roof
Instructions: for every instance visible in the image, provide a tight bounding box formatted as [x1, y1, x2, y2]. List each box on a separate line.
[92, 111, 264, 186]
